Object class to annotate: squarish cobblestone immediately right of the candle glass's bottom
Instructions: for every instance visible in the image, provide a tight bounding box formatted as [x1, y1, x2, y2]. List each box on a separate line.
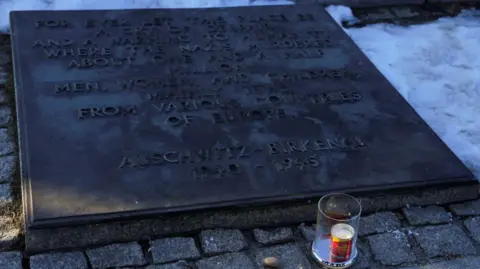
[367, 231, 416, 265]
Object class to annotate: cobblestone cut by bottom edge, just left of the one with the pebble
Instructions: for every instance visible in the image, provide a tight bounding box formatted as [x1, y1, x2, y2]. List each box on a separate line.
[195, 253, 255, 269]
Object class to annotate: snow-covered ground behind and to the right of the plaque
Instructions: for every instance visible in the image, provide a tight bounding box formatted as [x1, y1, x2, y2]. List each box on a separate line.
[0, 0, 480, 179]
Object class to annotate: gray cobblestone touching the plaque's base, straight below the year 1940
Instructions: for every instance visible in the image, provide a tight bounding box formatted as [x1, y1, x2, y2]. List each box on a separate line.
[200, 229, 247, 255]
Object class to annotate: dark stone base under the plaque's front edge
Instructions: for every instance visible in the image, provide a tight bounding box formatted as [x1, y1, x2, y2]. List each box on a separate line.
[26, 181, 480, 254]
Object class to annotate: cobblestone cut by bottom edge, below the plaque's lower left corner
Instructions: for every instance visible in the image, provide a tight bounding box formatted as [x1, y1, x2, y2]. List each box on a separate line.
[30, 252, 88, 269]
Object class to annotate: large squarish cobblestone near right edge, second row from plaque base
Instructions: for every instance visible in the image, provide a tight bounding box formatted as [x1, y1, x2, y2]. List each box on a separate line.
[413, 224, 475, 258]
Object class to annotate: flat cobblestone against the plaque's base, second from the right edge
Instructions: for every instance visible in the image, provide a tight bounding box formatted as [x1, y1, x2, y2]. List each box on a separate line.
[403, 206, 452, 225]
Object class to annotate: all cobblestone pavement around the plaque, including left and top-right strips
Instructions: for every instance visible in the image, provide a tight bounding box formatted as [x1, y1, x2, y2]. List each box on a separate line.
[0, 0, 480, 269]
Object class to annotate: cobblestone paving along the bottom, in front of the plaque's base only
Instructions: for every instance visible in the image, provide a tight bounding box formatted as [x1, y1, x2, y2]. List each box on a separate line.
[0, 200, 480, 269]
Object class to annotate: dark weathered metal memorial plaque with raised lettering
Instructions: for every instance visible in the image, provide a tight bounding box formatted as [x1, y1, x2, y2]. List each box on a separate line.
[11, 5, 472, 227]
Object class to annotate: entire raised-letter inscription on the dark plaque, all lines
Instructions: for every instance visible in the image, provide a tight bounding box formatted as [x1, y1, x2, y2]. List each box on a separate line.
[26, 8, 367, 180]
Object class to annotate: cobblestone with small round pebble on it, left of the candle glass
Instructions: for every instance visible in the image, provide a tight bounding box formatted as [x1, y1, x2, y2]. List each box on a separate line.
[255, 244, 312, 269]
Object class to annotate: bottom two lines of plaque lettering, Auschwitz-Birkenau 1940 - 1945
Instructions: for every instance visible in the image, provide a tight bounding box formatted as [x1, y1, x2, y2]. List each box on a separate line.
[118, 137, 367, 179]
